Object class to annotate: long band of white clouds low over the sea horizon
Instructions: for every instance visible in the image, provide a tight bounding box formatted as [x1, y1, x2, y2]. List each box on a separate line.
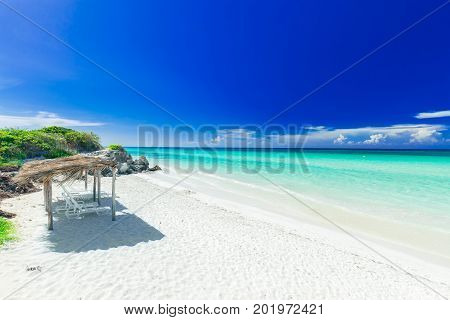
[139, 122, 450, 148]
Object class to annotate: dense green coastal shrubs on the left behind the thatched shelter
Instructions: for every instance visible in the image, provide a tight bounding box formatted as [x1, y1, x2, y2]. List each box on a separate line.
[0, 126, 101, 167]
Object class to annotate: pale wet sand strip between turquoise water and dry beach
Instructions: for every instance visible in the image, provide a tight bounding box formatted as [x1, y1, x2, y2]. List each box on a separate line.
[137, 166, 450, 268]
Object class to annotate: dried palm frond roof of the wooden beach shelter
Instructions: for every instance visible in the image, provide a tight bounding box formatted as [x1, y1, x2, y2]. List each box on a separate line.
[14, 154, 117, 184]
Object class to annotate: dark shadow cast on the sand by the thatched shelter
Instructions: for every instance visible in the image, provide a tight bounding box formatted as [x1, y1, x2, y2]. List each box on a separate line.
[48, 198, 164, 253]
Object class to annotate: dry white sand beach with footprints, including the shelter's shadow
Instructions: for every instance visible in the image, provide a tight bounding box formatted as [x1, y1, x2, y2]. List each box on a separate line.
[0, 171, 450, 299]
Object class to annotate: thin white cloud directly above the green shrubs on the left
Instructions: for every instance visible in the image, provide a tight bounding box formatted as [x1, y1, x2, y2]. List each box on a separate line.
[0, 111, 104, 128]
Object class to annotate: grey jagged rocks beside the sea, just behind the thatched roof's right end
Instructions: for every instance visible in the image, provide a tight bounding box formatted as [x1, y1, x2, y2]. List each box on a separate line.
[89, 149, 161, 177]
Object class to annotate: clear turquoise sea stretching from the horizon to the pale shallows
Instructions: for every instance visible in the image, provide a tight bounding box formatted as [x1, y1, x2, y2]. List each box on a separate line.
[126, 148, 450, 240]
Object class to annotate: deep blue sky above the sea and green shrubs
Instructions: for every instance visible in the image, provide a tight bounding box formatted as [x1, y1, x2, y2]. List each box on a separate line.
[0, 0, 450, 148]
